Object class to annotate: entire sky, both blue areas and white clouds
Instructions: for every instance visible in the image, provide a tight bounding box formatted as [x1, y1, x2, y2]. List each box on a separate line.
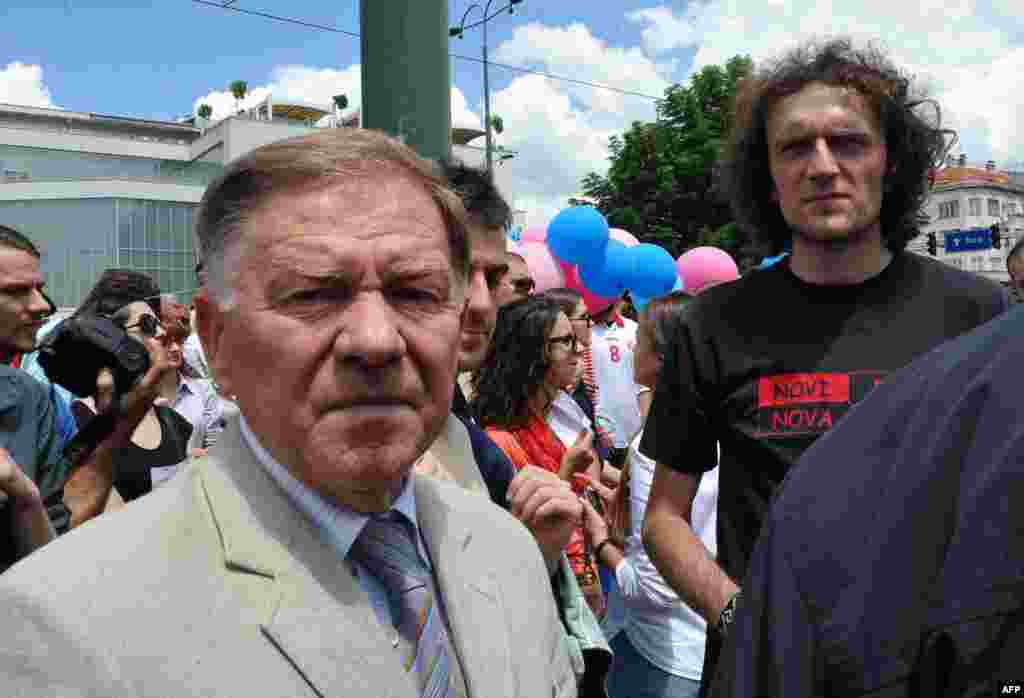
[0, 0, 1024, 223]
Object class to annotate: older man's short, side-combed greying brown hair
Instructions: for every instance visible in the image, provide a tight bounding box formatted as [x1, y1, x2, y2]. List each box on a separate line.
[196, 128, 470, 305]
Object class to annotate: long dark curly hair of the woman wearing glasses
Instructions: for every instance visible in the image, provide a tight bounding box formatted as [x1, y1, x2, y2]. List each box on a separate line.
[472, 295, 562, 429]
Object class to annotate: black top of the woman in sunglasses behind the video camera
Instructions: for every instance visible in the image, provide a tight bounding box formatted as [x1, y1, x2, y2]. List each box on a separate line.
[72, 401, 193, 501]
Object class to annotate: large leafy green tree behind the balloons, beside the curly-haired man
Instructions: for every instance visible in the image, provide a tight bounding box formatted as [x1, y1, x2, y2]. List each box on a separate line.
[582, 56, 754, 260]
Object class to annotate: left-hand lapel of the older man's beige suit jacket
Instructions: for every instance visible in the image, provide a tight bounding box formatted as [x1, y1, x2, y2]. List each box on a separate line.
[202, 422, 418, 698]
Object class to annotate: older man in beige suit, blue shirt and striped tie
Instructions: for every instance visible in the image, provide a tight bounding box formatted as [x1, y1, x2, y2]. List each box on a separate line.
[0, 129, 577, 698]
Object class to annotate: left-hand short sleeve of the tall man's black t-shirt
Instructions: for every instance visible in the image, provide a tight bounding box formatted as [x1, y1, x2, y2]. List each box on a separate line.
[640, 326, 718, 475]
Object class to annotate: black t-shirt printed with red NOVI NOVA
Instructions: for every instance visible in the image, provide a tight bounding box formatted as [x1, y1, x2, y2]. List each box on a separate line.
[640, 252, 1007, 581]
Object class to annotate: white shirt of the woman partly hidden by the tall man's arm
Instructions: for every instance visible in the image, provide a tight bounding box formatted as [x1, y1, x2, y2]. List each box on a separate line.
[615, 433, 718, 681]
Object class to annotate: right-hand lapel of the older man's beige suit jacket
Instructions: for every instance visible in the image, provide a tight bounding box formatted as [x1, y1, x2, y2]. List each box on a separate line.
[415, 477, 517, 698]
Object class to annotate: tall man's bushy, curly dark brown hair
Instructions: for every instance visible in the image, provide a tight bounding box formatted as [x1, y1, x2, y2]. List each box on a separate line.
[719, 39, 956, 255]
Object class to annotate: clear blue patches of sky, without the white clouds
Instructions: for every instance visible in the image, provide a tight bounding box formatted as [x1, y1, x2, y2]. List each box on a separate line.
[0, 0, 692, 119]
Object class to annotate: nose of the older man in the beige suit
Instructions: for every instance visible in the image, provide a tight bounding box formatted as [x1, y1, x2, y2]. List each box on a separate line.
[335, 292, 406, 368]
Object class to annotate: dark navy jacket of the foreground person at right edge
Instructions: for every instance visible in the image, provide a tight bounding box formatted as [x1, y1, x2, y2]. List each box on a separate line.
[714, 307, 1024, 698]
